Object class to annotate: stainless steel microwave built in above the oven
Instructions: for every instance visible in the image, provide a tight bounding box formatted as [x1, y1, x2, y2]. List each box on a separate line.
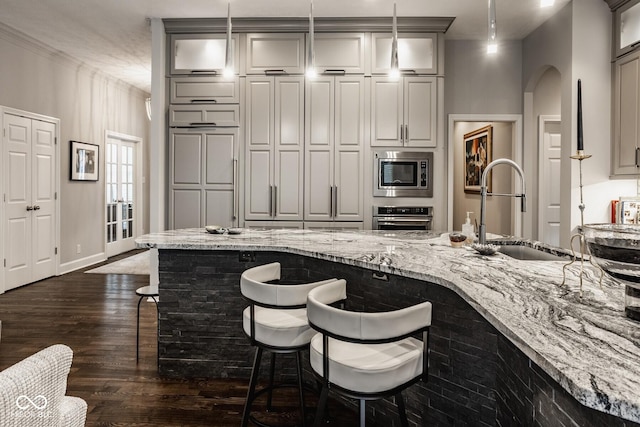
[373, 151, 433, 197]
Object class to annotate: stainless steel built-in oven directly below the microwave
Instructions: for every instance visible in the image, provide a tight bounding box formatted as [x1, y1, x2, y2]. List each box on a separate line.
[372, 206, 433, 231]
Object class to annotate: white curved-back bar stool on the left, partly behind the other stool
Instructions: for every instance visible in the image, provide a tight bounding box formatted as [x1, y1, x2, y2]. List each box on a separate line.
[240, 262, 336, 426]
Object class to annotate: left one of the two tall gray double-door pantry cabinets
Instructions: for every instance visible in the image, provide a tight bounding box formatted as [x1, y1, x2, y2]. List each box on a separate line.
[244, 76, 304, 221]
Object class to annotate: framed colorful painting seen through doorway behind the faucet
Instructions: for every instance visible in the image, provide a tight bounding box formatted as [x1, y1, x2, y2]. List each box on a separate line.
[464, 125, 493, 193]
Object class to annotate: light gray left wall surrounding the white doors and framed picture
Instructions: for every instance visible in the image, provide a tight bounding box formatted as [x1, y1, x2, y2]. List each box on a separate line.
[0, 23, 149, 272]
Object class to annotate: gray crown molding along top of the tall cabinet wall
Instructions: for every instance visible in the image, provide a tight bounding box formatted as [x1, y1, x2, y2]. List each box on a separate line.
[162, 17, 455, 34]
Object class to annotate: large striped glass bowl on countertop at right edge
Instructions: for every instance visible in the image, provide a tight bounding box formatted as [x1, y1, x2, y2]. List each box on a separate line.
[582, 224, 640, 320]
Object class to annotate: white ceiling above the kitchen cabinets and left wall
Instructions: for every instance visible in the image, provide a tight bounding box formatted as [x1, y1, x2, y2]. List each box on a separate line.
[0, 0, 570, 92]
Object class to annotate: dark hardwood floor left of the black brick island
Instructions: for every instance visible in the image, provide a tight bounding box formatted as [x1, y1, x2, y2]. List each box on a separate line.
[0, 253, 357, 427]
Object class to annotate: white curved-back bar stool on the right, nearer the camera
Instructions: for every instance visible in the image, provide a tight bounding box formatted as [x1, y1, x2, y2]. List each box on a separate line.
[307, 280, 431, 426]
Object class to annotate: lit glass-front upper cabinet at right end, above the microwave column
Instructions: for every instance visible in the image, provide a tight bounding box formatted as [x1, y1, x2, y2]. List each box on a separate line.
[371, 33, 438, 74]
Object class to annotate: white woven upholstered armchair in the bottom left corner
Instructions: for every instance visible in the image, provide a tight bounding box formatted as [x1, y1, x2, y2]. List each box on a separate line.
[0, 344, 87, 427]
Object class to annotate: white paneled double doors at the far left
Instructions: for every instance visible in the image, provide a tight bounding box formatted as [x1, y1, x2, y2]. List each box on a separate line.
[3, 113, 57, 290]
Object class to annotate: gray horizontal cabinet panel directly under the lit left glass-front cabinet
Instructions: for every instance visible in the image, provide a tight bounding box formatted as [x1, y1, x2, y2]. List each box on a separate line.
[169, 76, 240, 104]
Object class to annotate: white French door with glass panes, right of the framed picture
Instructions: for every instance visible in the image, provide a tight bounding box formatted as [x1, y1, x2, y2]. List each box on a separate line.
[105, 133, 141, 257]
